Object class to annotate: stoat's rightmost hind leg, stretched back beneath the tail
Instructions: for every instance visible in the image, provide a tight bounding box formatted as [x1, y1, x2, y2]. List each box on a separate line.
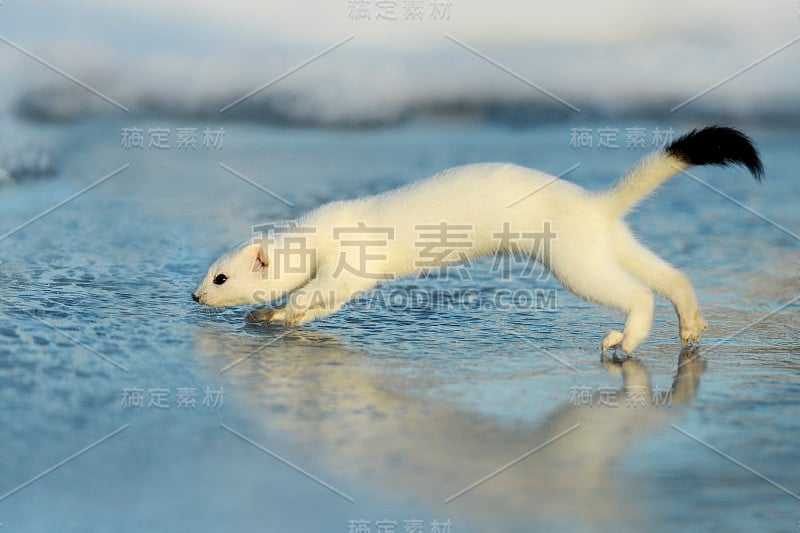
[615, 228, 708, 344]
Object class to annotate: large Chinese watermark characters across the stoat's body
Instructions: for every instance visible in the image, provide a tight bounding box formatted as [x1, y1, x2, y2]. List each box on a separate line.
[252, 221, 558, 281]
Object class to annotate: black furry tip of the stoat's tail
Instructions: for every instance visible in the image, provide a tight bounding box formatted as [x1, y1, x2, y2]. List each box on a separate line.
[666, 126, 764, 181]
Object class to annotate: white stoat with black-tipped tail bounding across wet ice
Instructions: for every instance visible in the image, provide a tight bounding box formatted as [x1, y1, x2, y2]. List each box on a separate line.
[192, 126, 763, 354]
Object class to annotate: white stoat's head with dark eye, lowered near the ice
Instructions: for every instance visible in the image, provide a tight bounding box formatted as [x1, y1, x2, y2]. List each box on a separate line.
[192, 242, 269, 307]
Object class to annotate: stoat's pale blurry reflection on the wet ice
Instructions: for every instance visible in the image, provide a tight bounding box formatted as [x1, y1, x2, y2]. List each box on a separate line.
[199, 329, 706, 531]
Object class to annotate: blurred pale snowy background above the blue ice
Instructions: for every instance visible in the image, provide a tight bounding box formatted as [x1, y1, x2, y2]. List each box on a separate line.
[0, 0, 800, 125]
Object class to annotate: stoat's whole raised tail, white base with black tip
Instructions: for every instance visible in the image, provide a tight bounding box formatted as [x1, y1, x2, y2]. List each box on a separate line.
[602, 126, 764, 216]
